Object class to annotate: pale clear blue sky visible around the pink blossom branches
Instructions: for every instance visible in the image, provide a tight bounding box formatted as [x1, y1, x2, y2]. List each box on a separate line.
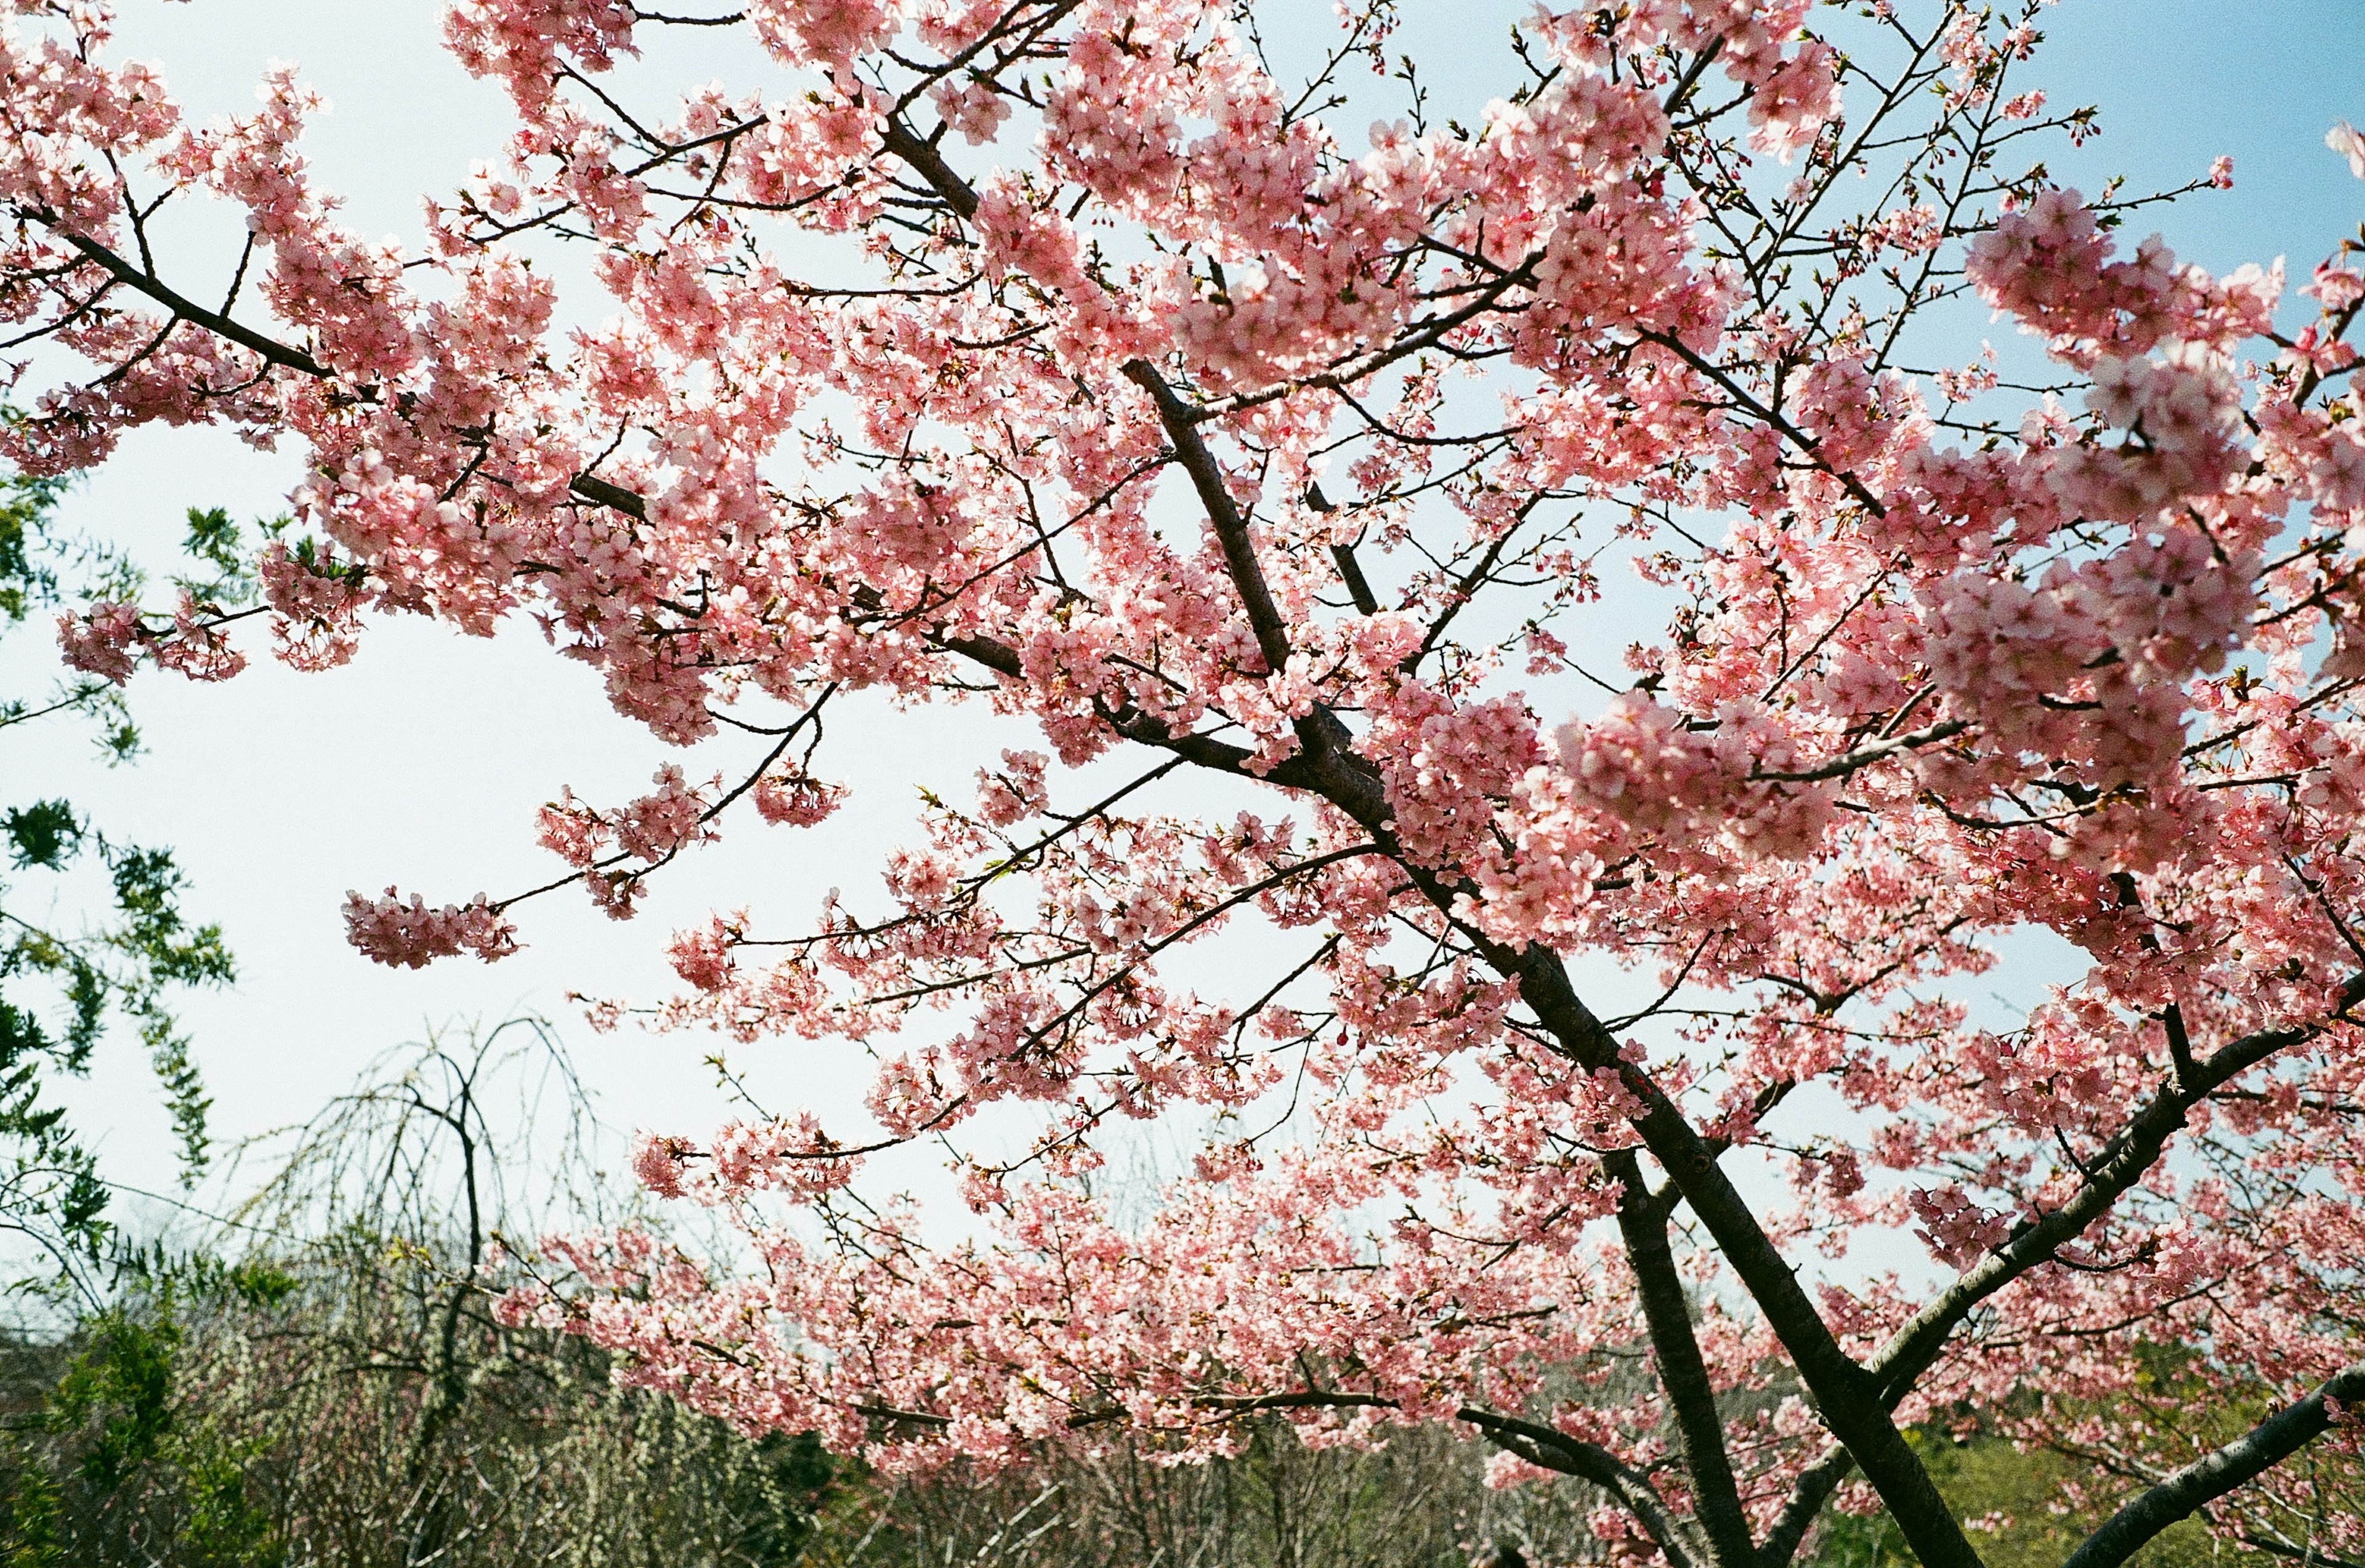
[0, 0, 2365, 1229]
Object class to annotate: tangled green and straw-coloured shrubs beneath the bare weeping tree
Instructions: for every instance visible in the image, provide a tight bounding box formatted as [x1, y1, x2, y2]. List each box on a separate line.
[0, 1232, 837, 1568]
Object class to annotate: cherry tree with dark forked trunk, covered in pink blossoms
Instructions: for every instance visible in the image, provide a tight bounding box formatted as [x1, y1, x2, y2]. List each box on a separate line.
[0, 0, 2365, 1568]
